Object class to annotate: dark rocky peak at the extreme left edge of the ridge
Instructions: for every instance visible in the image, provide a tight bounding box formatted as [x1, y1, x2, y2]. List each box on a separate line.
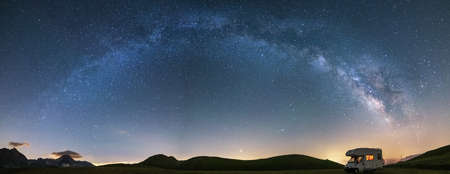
[0, 148, 28, 168]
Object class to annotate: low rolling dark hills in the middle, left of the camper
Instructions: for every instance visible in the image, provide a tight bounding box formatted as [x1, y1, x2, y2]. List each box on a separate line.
[132, 154, 343, 170]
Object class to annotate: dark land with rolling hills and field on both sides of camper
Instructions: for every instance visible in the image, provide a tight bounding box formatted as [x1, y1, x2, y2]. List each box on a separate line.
[0, 145, 450, 174]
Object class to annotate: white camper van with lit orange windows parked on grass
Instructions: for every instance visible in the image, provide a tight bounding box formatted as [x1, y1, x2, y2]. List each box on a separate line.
[345, 148, 384, 173]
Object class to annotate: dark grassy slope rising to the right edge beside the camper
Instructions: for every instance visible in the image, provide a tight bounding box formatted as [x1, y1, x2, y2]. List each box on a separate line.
[389, 145, 450, 170]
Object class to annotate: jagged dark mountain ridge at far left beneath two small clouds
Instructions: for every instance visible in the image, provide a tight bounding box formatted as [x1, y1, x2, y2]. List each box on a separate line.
[0, 148, 94, 168]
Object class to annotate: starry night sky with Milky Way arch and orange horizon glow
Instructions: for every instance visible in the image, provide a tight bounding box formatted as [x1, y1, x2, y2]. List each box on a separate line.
[0, 0, 450, 164]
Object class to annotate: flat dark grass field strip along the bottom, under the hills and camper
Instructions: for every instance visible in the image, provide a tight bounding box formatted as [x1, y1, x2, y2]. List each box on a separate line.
[0, 167, 450, 174]
